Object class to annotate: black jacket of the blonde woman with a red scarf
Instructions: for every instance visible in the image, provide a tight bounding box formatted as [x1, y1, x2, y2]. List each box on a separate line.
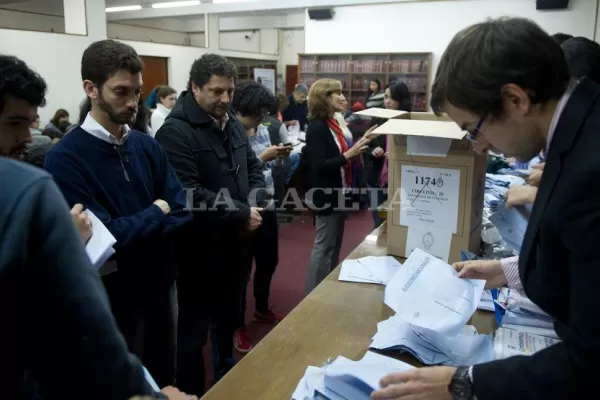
[303, 119, 346, 215]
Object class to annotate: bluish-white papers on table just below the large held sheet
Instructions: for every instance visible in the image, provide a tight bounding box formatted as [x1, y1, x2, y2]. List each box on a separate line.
[370, 316, 494, 366]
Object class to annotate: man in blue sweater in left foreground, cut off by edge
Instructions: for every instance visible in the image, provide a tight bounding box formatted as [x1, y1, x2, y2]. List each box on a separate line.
[0, 55, 189, 400]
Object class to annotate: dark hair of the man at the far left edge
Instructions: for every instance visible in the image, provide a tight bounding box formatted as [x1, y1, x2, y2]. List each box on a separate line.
[0, 55, 47, 113]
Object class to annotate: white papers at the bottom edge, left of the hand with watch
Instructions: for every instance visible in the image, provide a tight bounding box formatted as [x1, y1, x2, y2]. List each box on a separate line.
[292, 352, 414, 400]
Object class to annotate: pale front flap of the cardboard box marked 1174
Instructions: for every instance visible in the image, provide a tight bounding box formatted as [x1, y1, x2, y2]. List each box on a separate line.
[373, 119, 466, 140]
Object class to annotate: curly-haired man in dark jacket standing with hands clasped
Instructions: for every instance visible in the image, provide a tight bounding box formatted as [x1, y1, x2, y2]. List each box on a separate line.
[156, 54, 266, 395]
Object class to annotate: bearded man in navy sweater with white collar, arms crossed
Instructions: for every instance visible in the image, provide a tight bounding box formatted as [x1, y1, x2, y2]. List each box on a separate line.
[46, 40, 191, 386]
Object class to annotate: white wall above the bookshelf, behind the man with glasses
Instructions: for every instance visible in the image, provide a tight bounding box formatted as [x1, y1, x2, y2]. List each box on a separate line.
[305, 0, 597, 88]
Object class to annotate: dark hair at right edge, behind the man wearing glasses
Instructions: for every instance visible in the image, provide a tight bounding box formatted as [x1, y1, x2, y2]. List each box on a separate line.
[561, 37, 600, 83]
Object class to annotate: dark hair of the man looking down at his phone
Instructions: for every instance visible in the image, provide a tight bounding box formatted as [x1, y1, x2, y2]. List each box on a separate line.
[231, 81, 277, 117]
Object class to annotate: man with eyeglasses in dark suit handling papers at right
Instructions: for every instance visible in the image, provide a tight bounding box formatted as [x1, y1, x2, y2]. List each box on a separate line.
[372, 18, 600, 400]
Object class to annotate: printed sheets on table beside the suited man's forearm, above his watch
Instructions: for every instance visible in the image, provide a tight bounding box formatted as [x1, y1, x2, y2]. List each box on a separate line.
[494, 328, 560, 360]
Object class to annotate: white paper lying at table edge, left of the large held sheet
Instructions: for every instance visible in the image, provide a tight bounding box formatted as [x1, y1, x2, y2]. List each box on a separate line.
[339, 256, 402, 285]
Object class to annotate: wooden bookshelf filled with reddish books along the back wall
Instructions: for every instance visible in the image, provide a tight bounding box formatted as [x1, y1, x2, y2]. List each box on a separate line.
[298, 53, 431, 111]
